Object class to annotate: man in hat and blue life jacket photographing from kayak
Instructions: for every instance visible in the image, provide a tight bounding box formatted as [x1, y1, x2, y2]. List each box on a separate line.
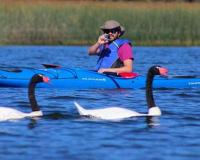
[88, 20, 133, 74]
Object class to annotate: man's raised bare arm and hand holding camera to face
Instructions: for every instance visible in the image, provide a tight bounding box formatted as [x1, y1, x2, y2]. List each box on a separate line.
[88, 34, 108, 55]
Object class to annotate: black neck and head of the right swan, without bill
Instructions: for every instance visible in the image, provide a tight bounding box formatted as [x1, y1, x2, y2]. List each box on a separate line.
[146, 66, 159, 109]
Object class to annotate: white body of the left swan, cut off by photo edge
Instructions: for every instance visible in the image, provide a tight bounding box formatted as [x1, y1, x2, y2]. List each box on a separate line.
[0, 107, 43, 121]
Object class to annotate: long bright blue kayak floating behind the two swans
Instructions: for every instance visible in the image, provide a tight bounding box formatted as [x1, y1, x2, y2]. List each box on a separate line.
[0, 68, 200, 89]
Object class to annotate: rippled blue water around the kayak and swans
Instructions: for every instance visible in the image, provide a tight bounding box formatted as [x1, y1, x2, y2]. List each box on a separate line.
[0, 46, 200, 160]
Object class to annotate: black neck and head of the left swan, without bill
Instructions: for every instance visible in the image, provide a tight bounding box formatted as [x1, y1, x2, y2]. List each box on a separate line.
[28, 74, 43, 112]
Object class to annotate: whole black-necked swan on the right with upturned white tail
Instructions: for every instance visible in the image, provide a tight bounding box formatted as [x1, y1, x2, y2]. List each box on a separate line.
[74, 66, 168, 120]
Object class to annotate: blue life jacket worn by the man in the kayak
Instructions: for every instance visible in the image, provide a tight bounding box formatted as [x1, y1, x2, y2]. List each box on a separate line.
[96, 39, 131, 70]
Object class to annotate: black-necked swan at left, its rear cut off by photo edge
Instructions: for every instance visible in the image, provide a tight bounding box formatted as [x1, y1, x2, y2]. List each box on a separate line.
[0, 74, 49, 121]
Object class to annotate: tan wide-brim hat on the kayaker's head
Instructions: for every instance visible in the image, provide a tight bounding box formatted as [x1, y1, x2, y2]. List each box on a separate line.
[100, 20, 125, 36]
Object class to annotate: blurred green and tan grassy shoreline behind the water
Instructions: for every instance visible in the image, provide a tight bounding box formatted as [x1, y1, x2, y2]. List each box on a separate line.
[0, 0, 200, 46]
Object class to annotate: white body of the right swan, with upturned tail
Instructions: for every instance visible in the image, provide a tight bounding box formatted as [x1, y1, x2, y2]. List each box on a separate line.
[74, 102, 161, 120]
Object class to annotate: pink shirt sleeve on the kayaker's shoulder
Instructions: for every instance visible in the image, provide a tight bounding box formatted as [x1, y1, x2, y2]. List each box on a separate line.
[118, 43, 134, 61]
